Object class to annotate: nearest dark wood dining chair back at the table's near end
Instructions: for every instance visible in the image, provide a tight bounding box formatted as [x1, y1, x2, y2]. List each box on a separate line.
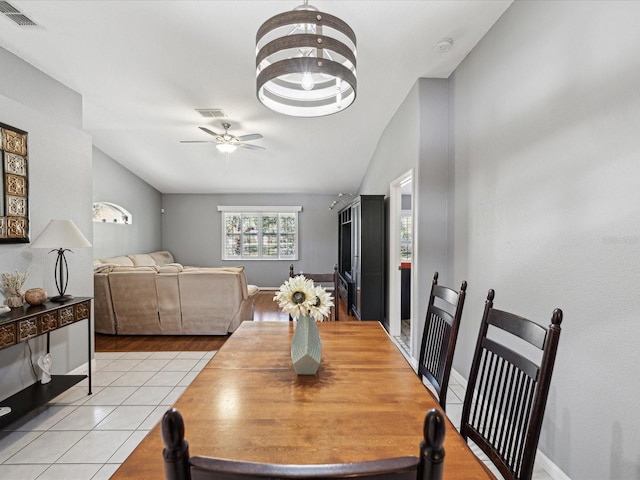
[162, 408, 445, 480]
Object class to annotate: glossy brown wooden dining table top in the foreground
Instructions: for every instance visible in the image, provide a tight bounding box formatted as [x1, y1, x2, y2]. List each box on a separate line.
[112, 321, 494, 480]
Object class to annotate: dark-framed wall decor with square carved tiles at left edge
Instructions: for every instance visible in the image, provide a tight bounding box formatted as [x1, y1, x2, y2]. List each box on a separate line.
[0, 123, 29, 243]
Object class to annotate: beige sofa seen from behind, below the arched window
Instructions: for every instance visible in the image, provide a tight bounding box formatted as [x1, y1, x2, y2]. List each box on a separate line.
[93, 251, 258, 335]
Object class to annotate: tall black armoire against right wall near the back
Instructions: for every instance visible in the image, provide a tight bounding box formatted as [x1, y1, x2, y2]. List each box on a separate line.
[338, 195, 385, 322]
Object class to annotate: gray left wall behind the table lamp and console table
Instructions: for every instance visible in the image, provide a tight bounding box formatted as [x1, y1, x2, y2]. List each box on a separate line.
[0, 48, 93, 398]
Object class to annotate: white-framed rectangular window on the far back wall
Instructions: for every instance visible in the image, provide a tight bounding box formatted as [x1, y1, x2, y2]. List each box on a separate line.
[218, 206, 302, 260]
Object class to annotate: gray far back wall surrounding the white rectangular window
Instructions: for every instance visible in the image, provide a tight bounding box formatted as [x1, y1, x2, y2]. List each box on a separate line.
[162, 194, 338, 288]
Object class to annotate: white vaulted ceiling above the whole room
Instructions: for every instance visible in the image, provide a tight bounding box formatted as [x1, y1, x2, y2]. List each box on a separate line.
[0, 0, 512, 194]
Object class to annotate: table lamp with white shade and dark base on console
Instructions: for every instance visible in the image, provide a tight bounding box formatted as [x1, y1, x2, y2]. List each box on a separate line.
[31, 220, 91, 303]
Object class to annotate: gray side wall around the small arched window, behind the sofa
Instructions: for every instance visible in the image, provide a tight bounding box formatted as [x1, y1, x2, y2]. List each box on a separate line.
[93, 147, 162, 258]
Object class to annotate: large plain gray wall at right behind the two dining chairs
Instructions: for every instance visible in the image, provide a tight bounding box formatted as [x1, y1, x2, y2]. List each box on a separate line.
[450, 1, 640, 480]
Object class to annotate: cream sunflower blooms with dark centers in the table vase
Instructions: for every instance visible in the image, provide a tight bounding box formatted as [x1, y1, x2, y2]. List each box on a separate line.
[273, 275, 333, 322]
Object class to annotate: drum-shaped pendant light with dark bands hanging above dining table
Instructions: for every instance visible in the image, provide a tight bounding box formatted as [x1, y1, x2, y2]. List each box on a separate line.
[256, 0, 357, 117]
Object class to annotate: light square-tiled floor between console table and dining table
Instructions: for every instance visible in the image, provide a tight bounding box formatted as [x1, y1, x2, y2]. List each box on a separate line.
[0, 352, 215, 480]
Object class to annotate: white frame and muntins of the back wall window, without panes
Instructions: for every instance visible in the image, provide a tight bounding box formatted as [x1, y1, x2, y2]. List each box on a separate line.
[218, 205, 302, 261]
